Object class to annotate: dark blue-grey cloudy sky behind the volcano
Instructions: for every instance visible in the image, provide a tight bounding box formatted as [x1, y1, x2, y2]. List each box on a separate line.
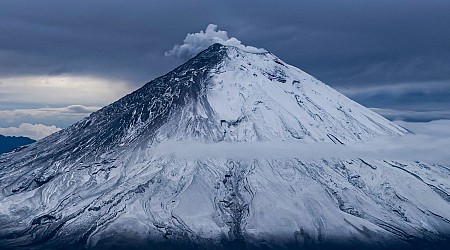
[0, 0, 450, 139]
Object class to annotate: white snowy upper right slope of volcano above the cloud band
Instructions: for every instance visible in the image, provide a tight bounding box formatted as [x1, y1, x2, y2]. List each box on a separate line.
[153, 44, 406, 143]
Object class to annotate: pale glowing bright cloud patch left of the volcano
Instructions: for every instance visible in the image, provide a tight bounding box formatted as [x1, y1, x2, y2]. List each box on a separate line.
[0, 74, 130, 128]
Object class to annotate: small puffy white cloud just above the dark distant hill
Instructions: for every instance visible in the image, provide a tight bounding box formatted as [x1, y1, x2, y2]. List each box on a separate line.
[0, 123, 61, 140]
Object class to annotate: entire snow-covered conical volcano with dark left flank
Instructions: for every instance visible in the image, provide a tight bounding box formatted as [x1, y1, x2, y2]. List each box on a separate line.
[0, 44, 450, 249]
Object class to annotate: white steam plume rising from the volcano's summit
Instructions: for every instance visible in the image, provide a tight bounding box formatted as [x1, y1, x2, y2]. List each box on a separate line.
[165, 24, 266, 58]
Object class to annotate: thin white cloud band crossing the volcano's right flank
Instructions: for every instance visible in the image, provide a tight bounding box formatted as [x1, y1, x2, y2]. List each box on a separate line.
[149, 120, 450, 164]
